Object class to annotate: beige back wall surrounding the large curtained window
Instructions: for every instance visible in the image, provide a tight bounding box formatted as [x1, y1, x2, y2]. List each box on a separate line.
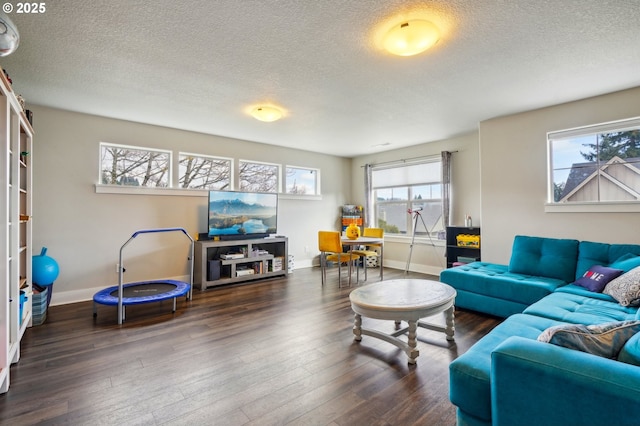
[351, 132, 481, 275]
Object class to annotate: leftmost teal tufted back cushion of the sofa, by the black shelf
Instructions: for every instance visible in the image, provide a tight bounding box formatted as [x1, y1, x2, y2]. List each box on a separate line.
[509, 235, 579, 283]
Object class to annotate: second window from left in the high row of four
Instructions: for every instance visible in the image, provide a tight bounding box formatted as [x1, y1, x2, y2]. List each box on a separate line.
[178, 152, 231, 190]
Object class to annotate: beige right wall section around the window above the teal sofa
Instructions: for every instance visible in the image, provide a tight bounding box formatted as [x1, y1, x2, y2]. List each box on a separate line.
[480, 87, 640, 264]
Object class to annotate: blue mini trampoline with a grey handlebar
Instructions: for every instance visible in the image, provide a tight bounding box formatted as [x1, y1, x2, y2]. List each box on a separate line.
[93, 228, 194, 324]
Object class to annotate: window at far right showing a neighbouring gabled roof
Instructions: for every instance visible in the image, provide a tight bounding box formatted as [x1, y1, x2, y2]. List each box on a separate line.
[547, 118, 640, 204]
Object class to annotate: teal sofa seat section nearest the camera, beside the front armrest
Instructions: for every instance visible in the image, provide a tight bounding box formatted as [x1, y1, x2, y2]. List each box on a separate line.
[449, 314, 560, 422]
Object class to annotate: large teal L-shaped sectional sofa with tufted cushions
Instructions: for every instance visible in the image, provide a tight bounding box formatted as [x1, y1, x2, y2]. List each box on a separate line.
[441, 236, 640, 426]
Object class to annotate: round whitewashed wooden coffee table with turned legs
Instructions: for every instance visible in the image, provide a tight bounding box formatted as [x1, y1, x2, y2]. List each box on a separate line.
[349, 279, 456, 364]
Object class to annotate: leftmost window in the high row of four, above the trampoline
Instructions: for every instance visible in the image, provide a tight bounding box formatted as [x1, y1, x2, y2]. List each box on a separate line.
[100, 143, 171, 188]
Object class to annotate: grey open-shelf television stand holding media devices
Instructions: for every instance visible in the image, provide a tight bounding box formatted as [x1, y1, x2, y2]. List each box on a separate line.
[193, 237, 288, 290]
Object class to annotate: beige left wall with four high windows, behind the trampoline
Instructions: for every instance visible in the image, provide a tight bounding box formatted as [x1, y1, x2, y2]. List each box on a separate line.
[30, 106, 351, 304]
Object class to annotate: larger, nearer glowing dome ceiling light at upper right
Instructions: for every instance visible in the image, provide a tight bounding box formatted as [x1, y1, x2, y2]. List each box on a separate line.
[383, 19, 440, 56]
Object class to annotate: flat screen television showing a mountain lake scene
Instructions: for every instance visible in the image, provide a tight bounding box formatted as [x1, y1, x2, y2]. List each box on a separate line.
[208, 191, 278, 240]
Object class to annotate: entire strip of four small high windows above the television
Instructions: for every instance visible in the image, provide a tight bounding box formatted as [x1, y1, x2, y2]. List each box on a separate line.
[96, 142, 320, 200]
